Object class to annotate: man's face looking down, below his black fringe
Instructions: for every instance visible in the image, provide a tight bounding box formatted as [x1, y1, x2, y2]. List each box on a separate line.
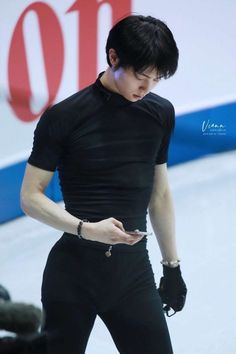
[113, 67, 160, 102]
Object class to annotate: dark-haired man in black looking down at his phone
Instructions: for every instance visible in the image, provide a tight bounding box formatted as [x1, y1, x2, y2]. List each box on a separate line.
[21, 16, 186, 354]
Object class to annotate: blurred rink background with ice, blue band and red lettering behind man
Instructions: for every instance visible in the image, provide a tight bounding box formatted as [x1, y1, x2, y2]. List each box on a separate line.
[0, 0, 236, 354]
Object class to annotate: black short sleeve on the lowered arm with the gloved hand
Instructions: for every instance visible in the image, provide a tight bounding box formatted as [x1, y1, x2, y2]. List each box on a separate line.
[156, 101, 175, 164]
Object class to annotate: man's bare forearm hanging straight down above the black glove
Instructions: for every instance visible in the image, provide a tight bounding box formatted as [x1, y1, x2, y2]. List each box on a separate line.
[149, 190, 178, 261]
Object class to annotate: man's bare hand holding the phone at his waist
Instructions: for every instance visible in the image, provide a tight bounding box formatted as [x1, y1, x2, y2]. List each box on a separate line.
[81, 218, 143, 245]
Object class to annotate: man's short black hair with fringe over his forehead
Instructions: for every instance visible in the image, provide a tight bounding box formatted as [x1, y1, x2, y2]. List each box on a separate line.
[106, 15, 179, 79]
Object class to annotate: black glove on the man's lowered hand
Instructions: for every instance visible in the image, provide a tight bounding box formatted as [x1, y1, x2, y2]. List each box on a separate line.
[158, 265, 187, 314]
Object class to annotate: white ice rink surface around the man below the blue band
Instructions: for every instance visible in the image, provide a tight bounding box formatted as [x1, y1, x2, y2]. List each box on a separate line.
[0, 151, 236, 354]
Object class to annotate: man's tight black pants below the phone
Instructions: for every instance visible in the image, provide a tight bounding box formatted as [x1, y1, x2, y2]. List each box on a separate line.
[42, 234, 173, 354]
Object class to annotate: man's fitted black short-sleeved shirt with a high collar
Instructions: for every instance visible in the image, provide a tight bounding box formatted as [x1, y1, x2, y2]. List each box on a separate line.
[28, 73, 174, 230]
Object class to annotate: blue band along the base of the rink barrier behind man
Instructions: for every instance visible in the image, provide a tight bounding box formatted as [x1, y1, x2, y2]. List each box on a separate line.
[0, 102, 236, 224]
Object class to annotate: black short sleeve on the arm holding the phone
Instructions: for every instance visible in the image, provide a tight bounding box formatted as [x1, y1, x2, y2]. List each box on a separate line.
[28, 108, 65, 171]
